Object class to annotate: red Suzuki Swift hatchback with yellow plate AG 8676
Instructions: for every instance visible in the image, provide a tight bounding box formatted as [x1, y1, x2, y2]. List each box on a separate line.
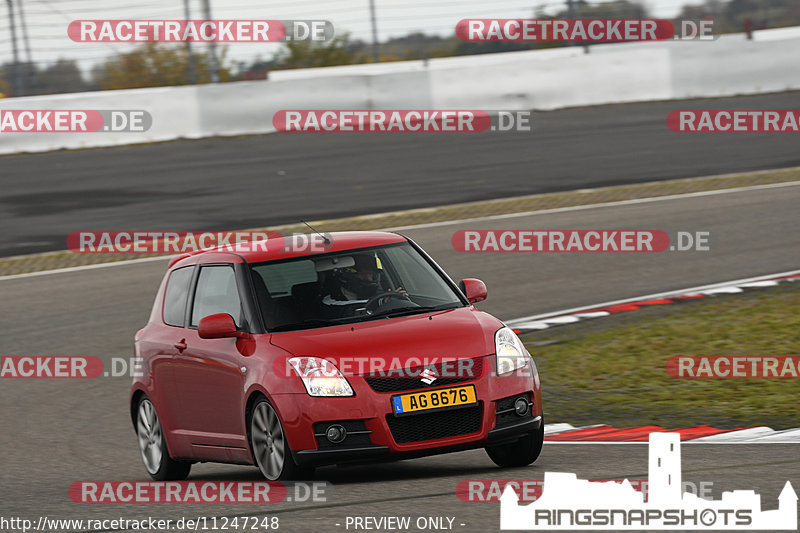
[130, 232, 544, 480]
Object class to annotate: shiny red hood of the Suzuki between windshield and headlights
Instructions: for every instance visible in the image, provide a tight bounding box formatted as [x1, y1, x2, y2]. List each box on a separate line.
[270, 306, 503, 363]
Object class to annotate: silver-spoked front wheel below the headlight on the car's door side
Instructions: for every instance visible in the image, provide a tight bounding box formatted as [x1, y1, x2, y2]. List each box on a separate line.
[250, 398, 314, 481]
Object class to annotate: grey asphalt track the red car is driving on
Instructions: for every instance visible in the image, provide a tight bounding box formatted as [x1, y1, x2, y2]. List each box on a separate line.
[0, 185, 800, 532]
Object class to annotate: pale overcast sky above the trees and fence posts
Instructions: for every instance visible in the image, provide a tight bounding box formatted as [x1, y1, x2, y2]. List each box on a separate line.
[0, 0, 688, 74]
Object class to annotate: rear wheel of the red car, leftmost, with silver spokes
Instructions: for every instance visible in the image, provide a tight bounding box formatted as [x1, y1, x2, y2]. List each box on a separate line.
[136, 396, 192, 481]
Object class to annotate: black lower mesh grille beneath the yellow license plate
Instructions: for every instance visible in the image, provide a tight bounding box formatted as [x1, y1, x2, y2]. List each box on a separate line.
[386, 403, 482, 444]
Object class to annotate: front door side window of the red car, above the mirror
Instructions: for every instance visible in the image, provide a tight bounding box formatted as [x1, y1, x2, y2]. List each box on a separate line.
[191, 265, 242, 327]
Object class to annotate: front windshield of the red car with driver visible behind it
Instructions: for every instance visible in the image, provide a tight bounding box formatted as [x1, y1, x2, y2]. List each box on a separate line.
[251, 243, 464, 331]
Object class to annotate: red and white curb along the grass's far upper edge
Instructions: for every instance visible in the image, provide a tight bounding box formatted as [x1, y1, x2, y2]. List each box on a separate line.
[506, 270, 800, 333]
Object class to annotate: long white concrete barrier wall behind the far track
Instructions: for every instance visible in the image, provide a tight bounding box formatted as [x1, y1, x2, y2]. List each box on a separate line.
[0, 28, 800, 154]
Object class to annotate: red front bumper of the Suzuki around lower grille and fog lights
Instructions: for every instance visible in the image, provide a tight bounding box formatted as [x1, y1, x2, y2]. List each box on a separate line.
[274, 356, 543, 466]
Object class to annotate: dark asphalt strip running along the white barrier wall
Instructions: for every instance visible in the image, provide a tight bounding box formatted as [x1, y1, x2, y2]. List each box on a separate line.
[0, 92, 800, 256]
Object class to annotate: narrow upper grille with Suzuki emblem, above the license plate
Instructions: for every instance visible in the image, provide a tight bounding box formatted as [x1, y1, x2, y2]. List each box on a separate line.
[364, 357, 483, 392]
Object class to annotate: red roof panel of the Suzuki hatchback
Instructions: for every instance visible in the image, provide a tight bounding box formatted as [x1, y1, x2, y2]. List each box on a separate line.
[169, 231, 408, 268]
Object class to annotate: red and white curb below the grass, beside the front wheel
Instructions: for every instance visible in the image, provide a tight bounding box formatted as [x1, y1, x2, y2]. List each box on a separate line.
[544, 424, 800, 444]
